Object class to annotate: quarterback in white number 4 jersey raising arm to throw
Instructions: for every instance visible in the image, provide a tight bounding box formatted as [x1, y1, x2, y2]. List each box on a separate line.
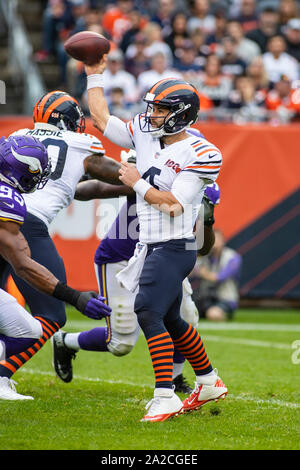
[82, 56, 227, 422]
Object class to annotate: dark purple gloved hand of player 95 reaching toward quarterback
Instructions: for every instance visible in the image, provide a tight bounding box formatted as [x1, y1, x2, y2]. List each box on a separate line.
[77, 291, 111, 320]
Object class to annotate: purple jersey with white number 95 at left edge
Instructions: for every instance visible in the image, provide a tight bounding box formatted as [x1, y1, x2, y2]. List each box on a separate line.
[0, 182, 26, 224]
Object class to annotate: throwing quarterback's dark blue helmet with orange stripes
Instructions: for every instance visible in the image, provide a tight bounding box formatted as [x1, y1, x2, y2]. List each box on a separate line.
[140, 78, 200, 137]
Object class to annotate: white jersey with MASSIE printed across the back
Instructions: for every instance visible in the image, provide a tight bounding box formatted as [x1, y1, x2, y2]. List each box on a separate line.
[13, 123, 105, 226]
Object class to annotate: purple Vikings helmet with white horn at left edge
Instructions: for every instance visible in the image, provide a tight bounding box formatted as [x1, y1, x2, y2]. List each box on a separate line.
[0, 135, 51, 193]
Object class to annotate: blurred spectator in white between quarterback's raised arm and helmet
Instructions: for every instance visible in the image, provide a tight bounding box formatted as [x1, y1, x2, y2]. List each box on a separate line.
[103, 49, 137, 104]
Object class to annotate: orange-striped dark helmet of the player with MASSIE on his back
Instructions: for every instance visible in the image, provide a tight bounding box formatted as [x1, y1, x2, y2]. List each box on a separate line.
[33, 90, 85, 132]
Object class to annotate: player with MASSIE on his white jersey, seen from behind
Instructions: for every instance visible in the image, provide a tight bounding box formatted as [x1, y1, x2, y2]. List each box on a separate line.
[0, 91, 120, 399]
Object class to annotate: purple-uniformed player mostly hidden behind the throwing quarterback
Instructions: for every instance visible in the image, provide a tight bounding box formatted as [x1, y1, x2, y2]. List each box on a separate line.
[53, 149, 220, 395]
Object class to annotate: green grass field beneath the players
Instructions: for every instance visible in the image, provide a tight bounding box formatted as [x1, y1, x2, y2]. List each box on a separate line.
[0, 309, 300, 450]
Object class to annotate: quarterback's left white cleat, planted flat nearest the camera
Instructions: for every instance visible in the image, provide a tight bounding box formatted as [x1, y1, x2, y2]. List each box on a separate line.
[141, 388, 183, 422]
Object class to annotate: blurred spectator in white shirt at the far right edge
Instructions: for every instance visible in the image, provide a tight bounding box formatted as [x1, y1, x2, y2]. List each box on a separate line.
[263, 36, 299, 83]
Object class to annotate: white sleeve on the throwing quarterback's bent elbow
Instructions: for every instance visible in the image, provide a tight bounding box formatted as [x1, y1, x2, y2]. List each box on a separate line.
[171, 172, 205, 206]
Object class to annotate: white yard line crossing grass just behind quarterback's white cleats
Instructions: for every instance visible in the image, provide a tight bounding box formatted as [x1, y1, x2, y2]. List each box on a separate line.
[19, 367, 300, 408]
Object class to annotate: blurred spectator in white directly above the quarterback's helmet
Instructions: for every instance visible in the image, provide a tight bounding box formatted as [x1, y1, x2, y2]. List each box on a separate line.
[137, 52, 182, 97]
